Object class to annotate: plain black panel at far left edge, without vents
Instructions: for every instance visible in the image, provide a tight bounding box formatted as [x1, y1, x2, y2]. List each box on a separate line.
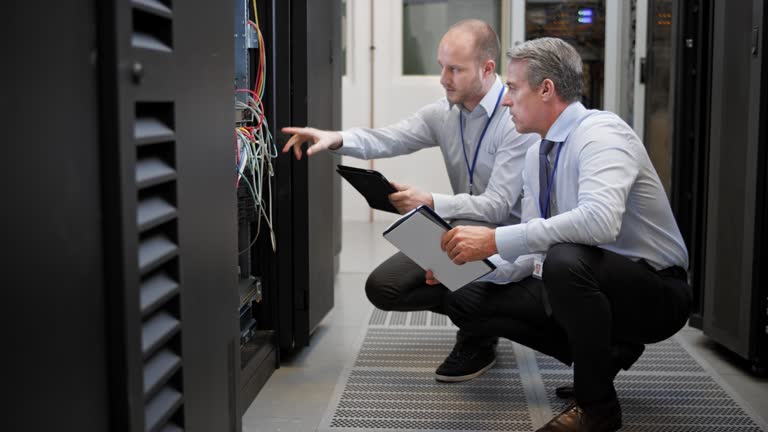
[0, 0, 111, 432]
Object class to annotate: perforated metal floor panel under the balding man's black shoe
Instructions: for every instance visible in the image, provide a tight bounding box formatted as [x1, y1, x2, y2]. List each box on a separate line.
[328, 330, 532, 431]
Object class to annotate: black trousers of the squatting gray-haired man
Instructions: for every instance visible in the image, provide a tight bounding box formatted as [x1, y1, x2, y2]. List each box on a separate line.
[445, 244, 691, 406]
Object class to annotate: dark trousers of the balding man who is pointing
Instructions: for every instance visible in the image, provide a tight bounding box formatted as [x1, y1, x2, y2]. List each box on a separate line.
[365, 252, 497, 348]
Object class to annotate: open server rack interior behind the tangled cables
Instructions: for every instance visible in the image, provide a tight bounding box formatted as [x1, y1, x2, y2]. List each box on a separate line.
[232, 0, 280, 418]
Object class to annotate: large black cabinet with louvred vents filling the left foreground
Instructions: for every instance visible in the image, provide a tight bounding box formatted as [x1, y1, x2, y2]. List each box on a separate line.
[0, 0, 237, 432]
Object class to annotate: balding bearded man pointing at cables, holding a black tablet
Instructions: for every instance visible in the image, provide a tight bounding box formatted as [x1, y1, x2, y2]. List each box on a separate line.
[283, 19, 539, 382]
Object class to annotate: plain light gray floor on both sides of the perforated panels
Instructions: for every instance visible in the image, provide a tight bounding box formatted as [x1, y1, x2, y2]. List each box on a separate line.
[243, 223, 768, 432]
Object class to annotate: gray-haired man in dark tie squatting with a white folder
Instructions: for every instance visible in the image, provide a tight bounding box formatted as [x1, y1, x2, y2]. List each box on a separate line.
[427, 38, 691, 432]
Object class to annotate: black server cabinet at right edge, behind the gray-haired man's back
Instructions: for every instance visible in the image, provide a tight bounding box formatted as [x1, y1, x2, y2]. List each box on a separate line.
[695, 0, 768, 368]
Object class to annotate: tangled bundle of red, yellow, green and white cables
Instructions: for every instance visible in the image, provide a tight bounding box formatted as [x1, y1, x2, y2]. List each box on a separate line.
[235, 0, 278, 254]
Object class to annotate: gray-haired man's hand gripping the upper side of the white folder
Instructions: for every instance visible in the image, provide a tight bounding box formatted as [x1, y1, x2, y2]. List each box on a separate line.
[440, 226, 497, 265]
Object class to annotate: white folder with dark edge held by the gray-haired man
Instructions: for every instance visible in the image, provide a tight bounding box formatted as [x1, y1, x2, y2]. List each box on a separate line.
[384, 205, 496, 291]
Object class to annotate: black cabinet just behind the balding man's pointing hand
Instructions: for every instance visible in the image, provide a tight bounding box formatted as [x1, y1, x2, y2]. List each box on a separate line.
[253, 0, 341, 350]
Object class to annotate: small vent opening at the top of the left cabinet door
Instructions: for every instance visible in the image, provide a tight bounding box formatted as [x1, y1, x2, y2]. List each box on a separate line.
[131, 0, 173, 52]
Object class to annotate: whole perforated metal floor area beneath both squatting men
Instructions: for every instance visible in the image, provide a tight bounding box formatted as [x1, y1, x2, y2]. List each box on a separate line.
[318, 310, 768, 432]
